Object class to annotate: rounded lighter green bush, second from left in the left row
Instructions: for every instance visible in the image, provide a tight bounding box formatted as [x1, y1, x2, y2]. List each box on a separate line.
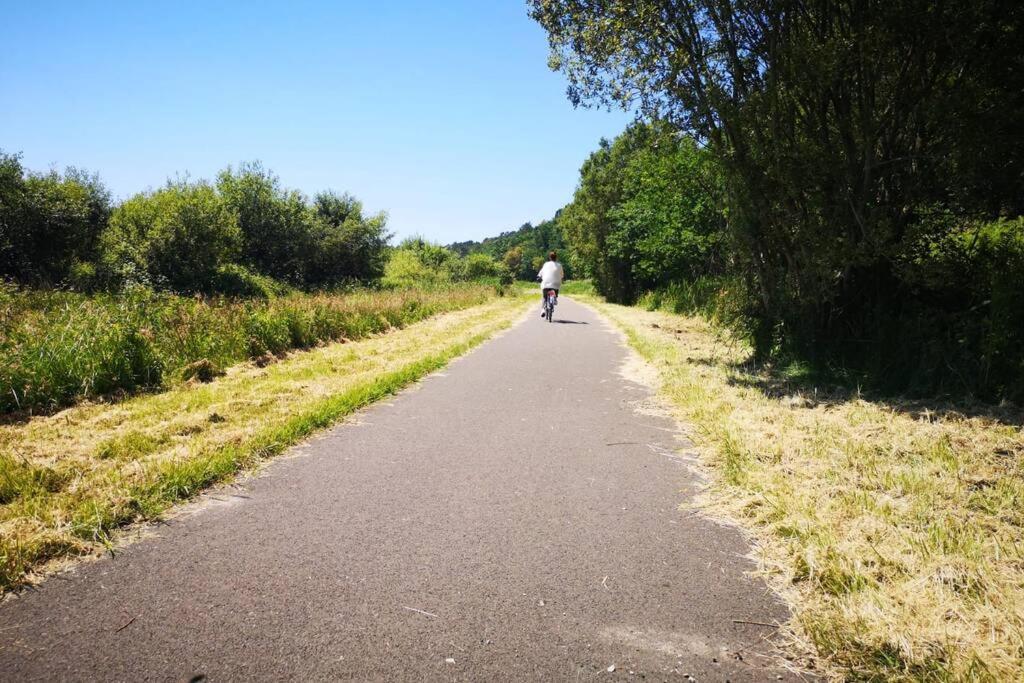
[101, 181, 242, 292]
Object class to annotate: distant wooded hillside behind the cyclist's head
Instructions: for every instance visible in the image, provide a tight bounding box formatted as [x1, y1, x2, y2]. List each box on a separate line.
[449, 220, 573, 282]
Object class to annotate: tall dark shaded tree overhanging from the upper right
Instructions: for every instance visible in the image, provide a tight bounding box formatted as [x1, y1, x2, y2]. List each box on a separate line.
[529, 0, 1024, 358]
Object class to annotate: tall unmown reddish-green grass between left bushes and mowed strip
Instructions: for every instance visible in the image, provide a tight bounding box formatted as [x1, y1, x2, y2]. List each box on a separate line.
[0, 284, 496, 413]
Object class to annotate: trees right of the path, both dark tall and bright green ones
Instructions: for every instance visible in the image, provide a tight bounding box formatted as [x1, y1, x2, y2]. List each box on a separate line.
[530, 0, 1024, 398]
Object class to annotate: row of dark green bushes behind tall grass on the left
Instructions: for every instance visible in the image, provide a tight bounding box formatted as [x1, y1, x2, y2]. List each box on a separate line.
[0, 153, 389, 296]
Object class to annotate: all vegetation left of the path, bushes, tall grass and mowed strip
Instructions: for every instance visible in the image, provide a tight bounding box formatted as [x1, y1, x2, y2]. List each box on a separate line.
[0, 153, 520, 593]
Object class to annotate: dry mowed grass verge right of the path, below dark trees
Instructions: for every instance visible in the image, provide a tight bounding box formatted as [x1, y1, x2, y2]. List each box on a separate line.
[590, 299, 1024, 681]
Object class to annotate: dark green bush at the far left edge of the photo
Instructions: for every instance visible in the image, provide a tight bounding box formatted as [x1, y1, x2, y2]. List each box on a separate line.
[0, 152, 111, 285]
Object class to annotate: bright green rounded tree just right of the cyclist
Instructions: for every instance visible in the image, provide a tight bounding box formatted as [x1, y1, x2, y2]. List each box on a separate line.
[559, 124, 725, 302]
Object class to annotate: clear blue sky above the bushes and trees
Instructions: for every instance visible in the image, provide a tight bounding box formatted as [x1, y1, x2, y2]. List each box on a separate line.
[0, 0, 630, 243]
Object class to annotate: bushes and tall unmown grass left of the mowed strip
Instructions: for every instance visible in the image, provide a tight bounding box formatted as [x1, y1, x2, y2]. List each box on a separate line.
[0, 153, 512, 416]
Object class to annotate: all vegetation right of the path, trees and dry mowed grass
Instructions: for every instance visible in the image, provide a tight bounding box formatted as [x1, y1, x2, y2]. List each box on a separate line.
[524, 0, 1024, 681]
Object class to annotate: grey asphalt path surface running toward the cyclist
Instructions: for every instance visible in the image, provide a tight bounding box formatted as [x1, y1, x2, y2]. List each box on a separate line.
[0, 299, 792, 681]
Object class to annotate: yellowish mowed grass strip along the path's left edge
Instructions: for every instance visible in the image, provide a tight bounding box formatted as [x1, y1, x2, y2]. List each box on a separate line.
[0, 297, 525, 592]
